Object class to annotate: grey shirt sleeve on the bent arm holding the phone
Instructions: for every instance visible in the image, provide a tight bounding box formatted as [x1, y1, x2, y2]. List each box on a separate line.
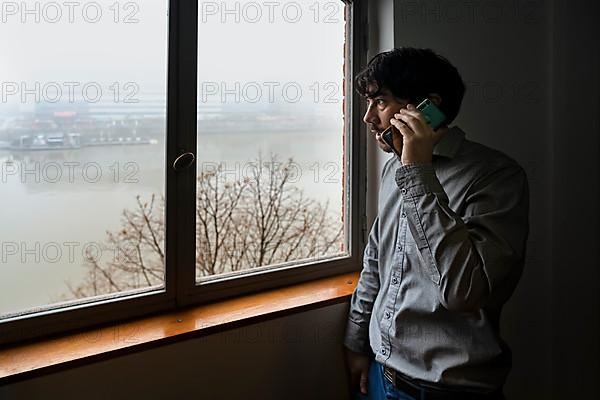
[396, 163, 529, 311]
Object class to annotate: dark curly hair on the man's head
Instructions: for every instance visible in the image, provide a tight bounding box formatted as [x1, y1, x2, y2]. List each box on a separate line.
[355, 47, 466, 124]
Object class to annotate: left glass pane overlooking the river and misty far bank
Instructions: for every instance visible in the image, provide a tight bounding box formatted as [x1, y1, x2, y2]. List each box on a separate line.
[0, 0, 168, 317]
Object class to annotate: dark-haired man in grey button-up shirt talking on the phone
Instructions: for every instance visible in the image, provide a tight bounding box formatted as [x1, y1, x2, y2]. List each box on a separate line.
[344, 47, 529, 400]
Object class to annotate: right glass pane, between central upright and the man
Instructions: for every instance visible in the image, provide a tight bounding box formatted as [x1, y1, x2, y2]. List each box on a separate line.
[196, 0, 347, 281]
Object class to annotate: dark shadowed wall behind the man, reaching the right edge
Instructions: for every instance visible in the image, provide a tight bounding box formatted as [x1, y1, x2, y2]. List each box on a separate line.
[394, 0, 600, 399]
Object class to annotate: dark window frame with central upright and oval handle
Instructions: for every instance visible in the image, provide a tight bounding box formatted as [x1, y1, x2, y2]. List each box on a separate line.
[0, 0, 368, 345]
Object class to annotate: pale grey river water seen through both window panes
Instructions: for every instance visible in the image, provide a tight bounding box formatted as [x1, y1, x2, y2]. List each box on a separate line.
[0, 130, 342, 314]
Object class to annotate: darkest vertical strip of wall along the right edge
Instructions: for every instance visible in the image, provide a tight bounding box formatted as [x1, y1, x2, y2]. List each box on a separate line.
[549, 0, 600, 399]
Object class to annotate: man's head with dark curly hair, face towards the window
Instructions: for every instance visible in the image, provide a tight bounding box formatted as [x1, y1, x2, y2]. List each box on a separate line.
[356, 47, 465, 152]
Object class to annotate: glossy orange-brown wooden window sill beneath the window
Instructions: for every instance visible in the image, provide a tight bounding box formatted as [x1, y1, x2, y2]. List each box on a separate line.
[0, 272, 358, 384]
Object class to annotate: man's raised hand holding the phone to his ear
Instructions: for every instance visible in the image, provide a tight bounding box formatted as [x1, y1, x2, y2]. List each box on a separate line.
[390, 104, 440, 165]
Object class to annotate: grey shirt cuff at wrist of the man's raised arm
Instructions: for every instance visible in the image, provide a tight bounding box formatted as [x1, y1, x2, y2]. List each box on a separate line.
[396, 163, 445, 197]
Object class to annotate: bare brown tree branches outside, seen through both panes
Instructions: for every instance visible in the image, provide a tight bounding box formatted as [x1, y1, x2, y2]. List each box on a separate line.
[67, 156, 344, 298]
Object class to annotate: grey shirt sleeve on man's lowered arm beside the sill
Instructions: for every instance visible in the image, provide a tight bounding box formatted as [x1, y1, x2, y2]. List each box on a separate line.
[344, 217, 379, 353]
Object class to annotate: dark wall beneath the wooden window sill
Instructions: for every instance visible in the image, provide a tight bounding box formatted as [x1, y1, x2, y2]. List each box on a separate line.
[0, 303, 348, 400]
